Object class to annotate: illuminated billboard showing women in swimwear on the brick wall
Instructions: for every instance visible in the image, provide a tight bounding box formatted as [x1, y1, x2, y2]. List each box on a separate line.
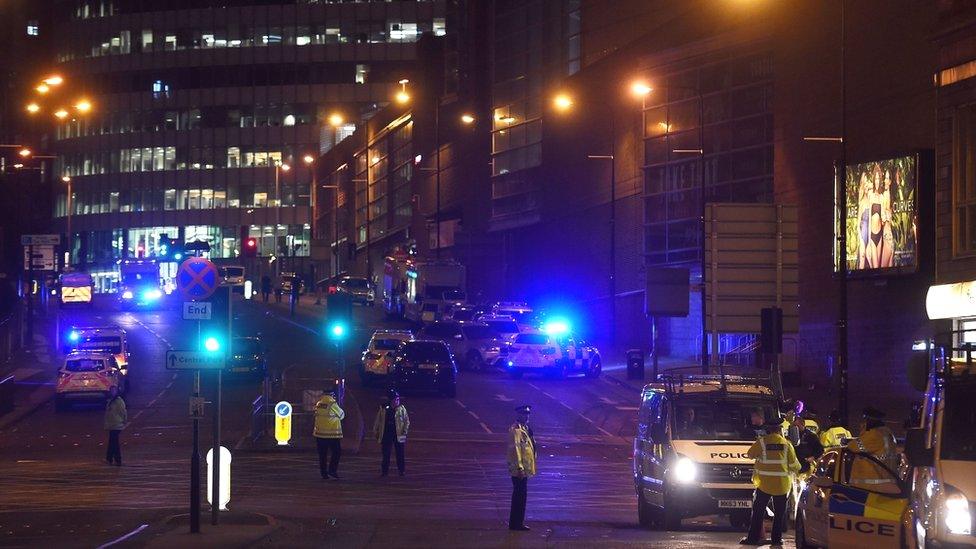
[836, 155, 918, 274]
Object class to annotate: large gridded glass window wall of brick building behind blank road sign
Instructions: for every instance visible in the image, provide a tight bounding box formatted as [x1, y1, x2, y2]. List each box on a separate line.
[644, 48, 773, 265]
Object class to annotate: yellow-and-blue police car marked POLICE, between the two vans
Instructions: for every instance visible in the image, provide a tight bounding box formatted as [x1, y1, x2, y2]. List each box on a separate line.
[796, 448, 916, 548]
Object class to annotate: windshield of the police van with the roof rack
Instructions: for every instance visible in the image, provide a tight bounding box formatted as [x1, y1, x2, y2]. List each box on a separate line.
[673, 398, 778, 441]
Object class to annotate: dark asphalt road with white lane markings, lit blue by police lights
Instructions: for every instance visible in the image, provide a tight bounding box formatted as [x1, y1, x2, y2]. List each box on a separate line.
[0, 299, 784, 547]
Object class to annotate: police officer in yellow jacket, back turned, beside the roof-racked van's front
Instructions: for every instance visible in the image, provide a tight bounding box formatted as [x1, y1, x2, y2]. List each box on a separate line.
[739, 420, 800, 545]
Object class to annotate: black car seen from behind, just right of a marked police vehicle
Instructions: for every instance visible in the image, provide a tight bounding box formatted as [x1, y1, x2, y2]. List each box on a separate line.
[390, 340, 457, 398]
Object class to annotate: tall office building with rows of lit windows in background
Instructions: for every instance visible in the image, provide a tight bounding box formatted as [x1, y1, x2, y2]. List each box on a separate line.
[47, 1, 447, 289]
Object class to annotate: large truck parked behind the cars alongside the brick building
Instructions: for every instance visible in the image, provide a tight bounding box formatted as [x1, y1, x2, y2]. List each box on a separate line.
[383, 256, 467, 324]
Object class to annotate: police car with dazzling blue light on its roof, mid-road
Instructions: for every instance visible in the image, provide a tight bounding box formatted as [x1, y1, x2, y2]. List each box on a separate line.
[504, 330, 602, 379]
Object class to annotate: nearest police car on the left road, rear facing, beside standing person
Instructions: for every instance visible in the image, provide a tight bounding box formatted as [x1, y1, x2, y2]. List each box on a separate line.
[54, 351, 125, 412]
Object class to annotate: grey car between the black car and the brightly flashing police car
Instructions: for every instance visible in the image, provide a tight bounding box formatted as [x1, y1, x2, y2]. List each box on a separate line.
[417, 321, 508, 370]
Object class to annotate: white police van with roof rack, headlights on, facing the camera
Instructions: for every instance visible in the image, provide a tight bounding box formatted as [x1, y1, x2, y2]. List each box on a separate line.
[633, 374, 779, 530]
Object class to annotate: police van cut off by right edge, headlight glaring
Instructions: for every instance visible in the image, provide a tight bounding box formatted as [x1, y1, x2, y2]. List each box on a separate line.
[905, 330, 976, 547]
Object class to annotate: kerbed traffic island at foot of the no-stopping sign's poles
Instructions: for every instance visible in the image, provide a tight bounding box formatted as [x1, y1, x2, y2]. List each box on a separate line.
[123, 509, 282, 549]
